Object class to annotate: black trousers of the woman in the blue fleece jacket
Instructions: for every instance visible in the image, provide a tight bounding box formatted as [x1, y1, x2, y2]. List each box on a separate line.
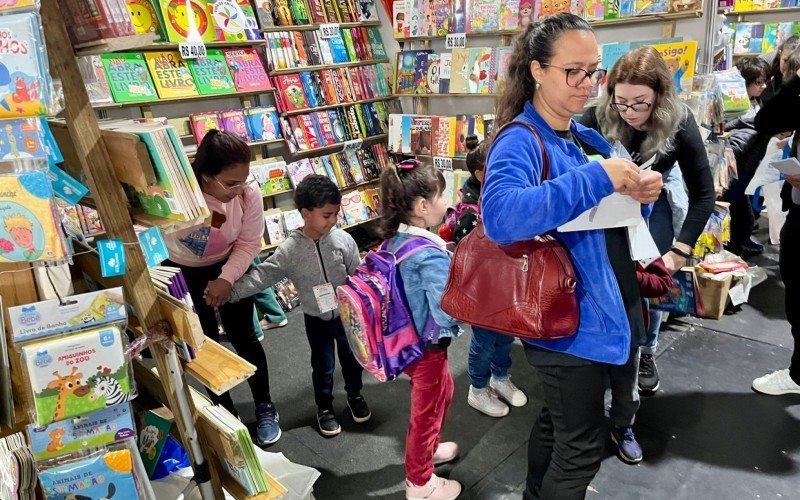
[524, 363, 609, 500]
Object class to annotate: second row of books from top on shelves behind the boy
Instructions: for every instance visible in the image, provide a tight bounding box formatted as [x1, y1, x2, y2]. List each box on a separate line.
[267, 27, 386, 71]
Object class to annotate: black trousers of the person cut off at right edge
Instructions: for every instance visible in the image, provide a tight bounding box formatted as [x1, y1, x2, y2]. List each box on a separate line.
[780, 206, 800, 384]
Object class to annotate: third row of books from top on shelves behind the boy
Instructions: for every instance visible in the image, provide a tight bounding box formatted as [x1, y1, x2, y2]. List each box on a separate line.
[275, 64, 390, 113]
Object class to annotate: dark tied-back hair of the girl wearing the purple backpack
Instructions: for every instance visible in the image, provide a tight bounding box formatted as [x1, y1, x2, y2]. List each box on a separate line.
[380, 160, 445, 238]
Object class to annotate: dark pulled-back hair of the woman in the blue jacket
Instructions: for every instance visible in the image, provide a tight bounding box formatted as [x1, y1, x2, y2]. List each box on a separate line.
[494, 12, 592, 130]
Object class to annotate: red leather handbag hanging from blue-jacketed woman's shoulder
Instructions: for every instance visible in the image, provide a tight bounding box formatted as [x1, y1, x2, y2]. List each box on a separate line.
[442, 122, 580, 340]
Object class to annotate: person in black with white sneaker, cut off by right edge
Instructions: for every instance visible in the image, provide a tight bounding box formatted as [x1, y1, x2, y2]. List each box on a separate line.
[753, 50, 800, 396]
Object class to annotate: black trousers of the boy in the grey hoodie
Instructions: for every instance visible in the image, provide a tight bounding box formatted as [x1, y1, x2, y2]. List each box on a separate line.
[305, 314, 363, 410]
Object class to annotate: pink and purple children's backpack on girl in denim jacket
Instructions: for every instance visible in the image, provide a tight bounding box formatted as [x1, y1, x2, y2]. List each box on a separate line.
[336, 237, 439, 382]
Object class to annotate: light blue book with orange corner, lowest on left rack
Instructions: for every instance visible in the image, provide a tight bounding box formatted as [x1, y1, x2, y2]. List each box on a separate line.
[39, 448, 140, 500]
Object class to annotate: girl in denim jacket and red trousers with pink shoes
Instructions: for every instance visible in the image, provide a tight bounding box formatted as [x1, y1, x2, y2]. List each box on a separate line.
[381, 160, 461, 500]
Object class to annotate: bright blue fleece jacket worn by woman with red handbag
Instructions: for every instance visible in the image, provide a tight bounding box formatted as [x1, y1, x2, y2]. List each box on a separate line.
[482, 103, 631, 365]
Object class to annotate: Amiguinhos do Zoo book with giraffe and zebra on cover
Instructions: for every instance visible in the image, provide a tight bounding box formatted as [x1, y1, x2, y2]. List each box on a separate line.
[21, 325, 133, 425]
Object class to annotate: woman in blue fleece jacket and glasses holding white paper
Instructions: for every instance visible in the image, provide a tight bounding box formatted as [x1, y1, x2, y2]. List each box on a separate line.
[482, 14, 662, 498]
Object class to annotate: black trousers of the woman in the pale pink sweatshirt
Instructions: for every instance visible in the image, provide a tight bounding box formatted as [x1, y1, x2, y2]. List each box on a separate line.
[164, 261, 272, 415]
